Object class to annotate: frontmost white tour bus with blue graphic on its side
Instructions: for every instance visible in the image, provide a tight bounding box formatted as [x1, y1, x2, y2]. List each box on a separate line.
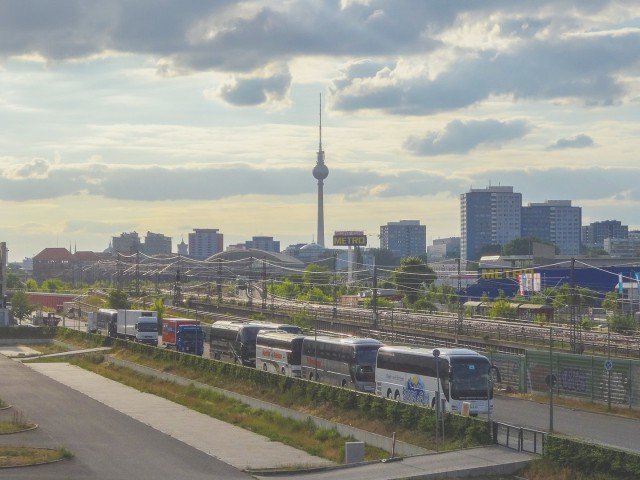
[376, 346, 499, 415]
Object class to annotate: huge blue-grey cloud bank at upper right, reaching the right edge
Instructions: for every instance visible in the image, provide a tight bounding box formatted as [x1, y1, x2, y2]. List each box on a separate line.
[332, 30, 640, 115]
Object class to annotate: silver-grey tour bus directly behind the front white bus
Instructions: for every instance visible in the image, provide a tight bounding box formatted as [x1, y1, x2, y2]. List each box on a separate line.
[301, 336, 382, 392]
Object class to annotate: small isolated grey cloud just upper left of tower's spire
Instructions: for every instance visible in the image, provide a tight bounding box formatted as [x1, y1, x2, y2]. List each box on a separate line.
[220, 66, 291, 106]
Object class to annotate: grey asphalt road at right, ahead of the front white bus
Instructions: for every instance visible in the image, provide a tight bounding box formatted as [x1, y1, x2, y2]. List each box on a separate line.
[493, 396, 640, 452]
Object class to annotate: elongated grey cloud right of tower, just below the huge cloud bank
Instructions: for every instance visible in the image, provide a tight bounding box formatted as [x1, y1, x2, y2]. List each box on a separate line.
[404, 119, 530, 156]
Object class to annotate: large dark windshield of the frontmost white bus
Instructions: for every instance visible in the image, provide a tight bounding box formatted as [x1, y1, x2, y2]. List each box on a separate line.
[450, 357, 491, 400]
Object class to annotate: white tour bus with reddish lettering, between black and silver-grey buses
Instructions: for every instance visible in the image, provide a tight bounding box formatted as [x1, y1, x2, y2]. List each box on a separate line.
[256, 330, 304, 378]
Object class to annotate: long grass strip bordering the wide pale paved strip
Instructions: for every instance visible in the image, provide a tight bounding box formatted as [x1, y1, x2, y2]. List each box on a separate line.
[72, 356, 388, 463]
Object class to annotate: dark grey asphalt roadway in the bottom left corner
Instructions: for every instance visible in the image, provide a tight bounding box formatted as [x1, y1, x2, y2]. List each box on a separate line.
[0, 355, 252, 480]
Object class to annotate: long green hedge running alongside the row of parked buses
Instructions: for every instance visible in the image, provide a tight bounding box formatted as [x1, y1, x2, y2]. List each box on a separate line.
[59, 329, 491, 446]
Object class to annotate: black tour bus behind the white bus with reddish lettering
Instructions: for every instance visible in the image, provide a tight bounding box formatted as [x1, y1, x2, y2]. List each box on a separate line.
[209, 320, 301, 367]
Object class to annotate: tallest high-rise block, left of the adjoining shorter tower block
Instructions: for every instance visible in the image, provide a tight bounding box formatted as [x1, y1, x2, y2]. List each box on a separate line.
[460, 186, 522, 261]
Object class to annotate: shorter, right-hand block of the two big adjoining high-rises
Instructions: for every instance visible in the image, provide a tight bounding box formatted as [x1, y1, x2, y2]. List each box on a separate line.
[522, 200, 582, 255]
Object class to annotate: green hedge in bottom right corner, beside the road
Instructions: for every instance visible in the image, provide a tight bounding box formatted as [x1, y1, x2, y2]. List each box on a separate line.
[544, 435, 640, 480]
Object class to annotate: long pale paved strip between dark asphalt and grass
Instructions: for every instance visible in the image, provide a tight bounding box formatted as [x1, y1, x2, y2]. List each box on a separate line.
[27, 363, 331, 469]
